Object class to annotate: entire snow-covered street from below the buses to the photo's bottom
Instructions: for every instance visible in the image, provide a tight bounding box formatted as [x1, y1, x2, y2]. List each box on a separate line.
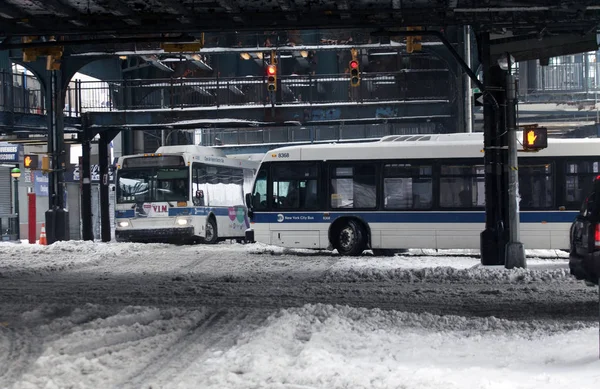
[0, 242, 600, 388]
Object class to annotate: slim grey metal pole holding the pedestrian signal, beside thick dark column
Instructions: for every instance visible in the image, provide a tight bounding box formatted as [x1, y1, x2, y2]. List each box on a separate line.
[504, 61, 527, 269]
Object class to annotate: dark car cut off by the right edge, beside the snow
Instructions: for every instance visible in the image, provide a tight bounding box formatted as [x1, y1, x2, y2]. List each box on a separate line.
[569, 176, 600, 285]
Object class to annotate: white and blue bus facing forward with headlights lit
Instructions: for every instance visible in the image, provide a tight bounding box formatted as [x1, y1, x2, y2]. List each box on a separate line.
[115, 146, 259, 243]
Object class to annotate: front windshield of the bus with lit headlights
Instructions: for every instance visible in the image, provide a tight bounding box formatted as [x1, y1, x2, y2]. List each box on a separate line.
[117, 167, 190, 203]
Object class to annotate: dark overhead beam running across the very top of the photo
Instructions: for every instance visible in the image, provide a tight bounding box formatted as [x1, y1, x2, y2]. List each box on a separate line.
[0, 8, 600, 35]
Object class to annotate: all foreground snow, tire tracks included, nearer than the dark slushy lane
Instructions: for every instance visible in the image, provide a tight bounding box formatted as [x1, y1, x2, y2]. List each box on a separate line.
[0, 304, 600, 389]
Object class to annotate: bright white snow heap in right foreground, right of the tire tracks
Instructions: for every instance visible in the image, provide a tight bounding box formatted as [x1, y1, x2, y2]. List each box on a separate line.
[173, 305, 600, 389]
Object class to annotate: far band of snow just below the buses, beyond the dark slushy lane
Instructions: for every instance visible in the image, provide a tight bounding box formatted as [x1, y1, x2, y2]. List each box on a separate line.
[0, 241, 576, 283]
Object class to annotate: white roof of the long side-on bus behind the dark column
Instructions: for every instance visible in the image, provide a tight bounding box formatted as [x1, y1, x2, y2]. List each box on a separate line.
[263, 132, 600, 162]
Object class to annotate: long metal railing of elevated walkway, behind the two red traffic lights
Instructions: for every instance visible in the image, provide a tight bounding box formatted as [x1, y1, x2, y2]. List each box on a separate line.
[0, 69, 455, 116]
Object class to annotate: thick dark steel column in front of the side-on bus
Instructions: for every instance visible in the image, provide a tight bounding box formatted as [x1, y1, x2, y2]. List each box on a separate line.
[479, 33, 509, 265]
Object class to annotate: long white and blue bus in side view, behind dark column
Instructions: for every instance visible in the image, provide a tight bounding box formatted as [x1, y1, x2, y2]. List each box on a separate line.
[246, 133, 600, 255]
